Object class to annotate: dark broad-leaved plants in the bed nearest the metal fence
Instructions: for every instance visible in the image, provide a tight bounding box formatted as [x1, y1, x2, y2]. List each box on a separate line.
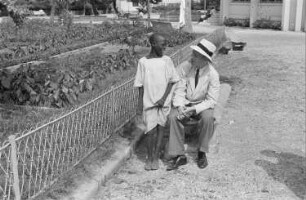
[0, 50, 138, 108]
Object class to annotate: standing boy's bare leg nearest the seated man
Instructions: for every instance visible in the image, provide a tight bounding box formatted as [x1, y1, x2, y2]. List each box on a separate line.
[152, 125, 165, 170]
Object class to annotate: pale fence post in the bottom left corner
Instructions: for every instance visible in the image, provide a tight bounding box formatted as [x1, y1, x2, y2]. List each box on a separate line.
[9, 135, 21, 200]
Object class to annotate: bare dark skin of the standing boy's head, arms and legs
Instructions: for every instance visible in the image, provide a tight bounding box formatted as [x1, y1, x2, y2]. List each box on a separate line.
[136, 34, 174, 170]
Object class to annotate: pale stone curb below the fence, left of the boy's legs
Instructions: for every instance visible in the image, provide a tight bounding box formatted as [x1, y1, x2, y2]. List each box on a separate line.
[61, 128, 143, 200]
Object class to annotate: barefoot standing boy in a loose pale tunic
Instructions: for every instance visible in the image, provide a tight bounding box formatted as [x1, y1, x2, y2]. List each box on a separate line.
[134, 34, 180, 170]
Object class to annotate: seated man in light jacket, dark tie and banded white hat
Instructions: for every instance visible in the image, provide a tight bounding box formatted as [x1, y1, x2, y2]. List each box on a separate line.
[167, 39, 220, 171]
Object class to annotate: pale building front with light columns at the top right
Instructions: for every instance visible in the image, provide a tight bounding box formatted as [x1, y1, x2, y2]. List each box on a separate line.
[220, 0, 306, 31]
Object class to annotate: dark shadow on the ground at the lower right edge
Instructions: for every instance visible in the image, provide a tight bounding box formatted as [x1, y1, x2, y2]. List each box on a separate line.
[255, 150, 306, 199]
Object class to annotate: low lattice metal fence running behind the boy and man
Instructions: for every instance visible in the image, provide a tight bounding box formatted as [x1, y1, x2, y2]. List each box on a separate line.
[0, 38, 206, 200]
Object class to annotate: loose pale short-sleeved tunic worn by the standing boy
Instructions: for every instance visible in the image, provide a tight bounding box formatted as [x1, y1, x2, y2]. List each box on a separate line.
[134, 56, 180, 133]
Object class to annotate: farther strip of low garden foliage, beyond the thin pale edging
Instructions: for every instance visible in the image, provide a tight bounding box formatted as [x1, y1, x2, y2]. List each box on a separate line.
[0, 20, 147, 67]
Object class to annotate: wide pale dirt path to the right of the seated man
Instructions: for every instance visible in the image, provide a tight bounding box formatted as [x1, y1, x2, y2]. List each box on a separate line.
[92, 29, 306, 200]
